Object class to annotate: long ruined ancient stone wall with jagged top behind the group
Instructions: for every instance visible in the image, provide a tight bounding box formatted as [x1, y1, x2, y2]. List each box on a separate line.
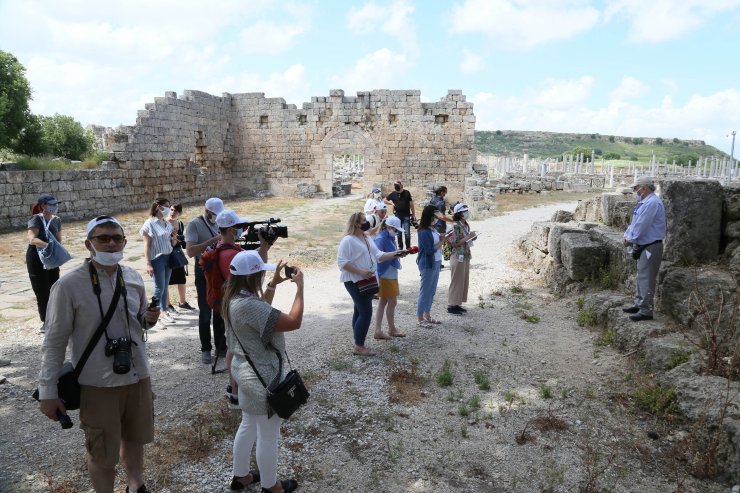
[0, 90, 475, 230]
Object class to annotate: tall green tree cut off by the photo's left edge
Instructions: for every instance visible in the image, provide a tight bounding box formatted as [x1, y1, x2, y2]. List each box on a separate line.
[0, 51, 31, 148]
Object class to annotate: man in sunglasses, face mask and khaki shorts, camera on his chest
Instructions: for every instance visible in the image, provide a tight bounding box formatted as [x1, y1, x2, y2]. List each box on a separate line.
[39, 216, 159, 493]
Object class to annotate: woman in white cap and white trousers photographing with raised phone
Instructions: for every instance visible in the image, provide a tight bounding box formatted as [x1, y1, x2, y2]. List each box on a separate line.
[221, 250, 303, 493]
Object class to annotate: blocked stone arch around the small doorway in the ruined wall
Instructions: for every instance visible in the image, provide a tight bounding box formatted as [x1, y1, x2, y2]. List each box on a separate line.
[312, 125, 381, 196]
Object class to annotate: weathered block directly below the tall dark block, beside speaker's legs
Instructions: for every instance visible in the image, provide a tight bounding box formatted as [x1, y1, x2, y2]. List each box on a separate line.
[657, 265, 737, 329]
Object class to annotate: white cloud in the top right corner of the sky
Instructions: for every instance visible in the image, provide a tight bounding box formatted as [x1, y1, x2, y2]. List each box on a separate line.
[605, 0, 740, 43]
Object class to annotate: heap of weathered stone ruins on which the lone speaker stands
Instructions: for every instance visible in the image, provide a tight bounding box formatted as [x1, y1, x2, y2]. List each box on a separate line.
[520, 179, 740, 483]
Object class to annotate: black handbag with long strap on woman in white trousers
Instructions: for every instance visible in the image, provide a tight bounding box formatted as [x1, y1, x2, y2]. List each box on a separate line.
[229, 322, 311, 419]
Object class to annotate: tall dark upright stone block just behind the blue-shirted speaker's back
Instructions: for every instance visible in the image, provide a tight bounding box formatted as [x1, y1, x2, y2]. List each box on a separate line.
[660, 180, 724, 263]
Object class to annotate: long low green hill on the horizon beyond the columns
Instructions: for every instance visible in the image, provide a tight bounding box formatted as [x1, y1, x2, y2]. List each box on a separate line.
[475, 130, 729, 164]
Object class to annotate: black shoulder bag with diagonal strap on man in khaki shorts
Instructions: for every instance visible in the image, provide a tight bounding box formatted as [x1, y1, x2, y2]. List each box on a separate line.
[32, 264, 125, 411]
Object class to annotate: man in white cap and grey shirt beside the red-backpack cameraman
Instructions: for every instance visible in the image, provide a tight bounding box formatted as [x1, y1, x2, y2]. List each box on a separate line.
[185, 197, 226, 365]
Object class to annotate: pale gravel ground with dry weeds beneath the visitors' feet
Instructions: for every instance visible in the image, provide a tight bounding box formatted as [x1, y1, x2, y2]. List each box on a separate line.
[0, 200, 727, 493]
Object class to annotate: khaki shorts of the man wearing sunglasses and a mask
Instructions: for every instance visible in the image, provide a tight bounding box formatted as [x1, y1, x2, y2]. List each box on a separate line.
[80, 378, 154, 467]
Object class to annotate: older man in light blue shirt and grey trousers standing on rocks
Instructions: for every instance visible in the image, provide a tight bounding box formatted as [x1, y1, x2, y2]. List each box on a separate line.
[622, 176, 666, 322]
